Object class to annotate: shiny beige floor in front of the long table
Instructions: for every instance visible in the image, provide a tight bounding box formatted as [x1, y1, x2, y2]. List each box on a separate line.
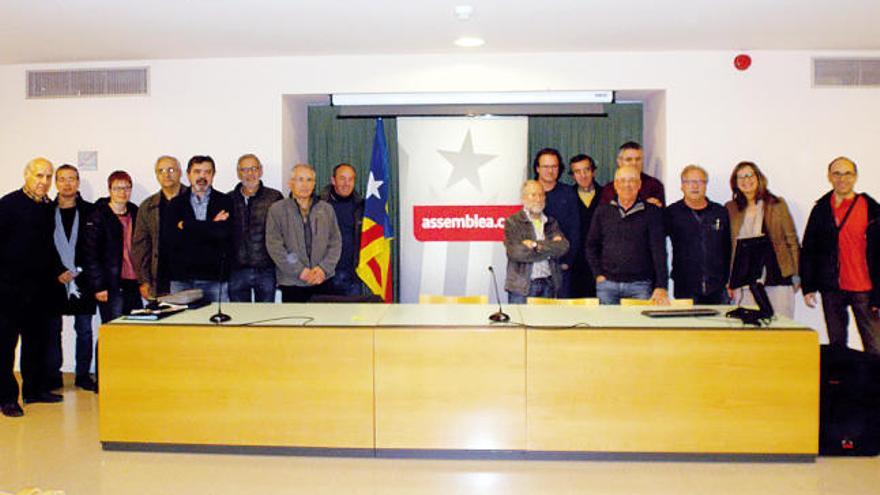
[0, 388, 880, 495]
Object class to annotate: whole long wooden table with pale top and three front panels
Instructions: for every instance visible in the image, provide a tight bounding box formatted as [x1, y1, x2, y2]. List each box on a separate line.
[100, 304, 819, 460]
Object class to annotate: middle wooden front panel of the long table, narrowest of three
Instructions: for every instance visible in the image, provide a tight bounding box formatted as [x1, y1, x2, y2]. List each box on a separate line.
[375, 328, 526, 450]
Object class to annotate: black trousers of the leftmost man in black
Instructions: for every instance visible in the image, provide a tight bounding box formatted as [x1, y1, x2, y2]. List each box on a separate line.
[0, 307, 53, 404]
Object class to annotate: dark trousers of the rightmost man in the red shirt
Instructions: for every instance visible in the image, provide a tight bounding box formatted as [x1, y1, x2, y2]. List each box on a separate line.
[822, 290, 880, 355]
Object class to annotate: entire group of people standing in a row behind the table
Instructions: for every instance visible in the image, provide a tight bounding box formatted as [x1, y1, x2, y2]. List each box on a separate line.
[0, 142, 880, 417]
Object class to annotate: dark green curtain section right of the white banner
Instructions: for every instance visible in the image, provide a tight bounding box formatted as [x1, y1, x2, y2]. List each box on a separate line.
[528, 103, 642, 184]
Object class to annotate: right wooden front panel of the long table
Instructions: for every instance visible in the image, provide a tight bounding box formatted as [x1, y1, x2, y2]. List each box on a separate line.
[528, 330, 819, 454]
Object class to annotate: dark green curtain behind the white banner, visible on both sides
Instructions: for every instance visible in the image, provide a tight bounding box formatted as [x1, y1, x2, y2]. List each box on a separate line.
[308, 104, 642, 301]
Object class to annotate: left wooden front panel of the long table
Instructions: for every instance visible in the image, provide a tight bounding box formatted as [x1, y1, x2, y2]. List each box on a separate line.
[100, 325, 373, 448]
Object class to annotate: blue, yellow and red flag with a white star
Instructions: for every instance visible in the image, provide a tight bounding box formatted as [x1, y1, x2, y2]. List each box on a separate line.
[357, 119, 394, 303]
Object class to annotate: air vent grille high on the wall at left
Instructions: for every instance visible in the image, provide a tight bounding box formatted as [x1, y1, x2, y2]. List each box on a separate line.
[27, 67, 150, 98]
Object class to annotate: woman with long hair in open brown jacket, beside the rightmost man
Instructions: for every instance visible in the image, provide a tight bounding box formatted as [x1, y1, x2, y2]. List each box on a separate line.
[724, 162, 800, 318]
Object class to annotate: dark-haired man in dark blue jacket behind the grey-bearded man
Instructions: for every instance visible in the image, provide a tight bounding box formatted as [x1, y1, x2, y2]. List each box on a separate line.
[532, 148, 582, 299]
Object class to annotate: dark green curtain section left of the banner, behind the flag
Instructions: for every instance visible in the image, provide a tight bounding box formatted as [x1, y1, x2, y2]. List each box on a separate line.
[309, 106, 400, 301]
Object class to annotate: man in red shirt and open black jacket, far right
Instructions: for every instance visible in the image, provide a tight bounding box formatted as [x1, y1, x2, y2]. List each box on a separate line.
[800, 157, 880, 355]
